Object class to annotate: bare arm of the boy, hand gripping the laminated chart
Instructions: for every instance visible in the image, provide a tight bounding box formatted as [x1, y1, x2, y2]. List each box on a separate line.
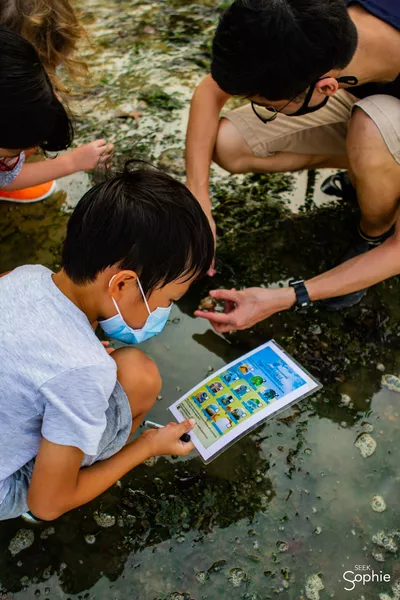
[28, 419, 194, 521]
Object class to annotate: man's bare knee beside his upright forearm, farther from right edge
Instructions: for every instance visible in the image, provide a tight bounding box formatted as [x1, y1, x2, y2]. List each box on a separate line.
[213, 119, 253, 173]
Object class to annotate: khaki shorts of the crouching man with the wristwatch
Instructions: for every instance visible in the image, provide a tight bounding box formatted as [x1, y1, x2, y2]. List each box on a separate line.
[224, 90, 400, 164]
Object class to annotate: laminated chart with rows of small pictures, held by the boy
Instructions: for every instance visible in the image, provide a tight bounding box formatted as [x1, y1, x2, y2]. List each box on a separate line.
[169, 340, 322, 462]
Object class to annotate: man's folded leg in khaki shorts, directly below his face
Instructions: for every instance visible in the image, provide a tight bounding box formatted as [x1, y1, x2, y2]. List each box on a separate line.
[214, 90, 356, 173]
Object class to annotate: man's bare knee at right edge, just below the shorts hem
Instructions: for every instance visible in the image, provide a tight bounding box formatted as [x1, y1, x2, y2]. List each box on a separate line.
[347, 107, 397, 179]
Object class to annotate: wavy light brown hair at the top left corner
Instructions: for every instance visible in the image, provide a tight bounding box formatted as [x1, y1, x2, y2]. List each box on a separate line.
[0, 0, 88, 92]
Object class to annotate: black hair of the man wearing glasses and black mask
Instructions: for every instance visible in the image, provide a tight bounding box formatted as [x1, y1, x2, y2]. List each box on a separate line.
[211, 0, 358, 100]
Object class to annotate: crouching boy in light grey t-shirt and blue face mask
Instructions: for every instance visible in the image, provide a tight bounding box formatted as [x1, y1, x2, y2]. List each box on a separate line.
[0, 166, 214, 520]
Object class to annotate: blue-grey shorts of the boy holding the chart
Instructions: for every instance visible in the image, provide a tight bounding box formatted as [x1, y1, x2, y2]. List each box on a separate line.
[0, 381, 132, 521]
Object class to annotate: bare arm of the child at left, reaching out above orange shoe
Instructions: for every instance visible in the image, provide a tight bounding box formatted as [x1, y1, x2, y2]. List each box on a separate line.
[3, 140, 114, 190]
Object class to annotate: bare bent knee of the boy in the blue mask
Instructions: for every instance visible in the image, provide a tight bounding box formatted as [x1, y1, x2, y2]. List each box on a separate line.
[111, 348, 162, 410]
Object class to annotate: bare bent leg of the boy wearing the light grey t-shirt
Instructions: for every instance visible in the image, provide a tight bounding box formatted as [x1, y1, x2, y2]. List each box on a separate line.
[111, 348, 162, 433]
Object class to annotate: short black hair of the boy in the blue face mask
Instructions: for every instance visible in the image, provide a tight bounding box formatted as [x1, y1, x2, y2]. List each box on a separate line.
[61, 161, 214, 295]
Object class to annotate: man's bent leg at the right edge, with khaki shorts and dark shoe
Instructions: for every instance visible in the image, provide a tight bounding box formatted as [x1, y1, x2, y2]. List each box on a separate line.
[325, 95, 400, 310]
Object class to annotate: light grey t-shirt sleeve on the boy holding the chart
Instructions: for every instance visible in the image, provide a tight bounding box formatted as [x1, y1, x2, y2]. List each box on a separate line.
[38, 364, 117, 456]
